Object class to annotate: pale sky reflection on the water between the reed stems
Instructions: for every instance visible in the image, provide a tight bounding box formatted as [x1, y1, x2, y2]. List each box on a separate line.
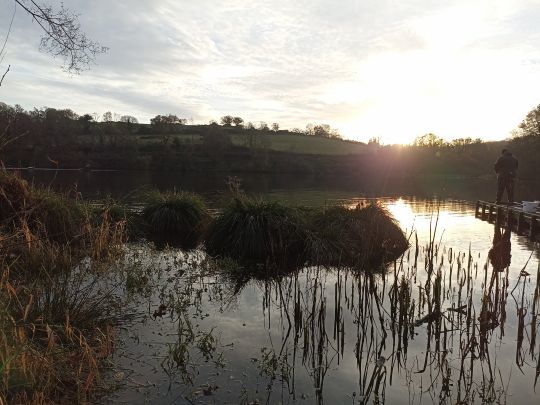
[107, 199, 540, 404]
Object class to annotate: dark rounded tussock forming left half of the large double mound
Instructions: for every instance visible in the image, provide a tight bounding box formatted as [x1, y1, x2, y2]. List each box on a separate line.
[205, 197, 306, 264]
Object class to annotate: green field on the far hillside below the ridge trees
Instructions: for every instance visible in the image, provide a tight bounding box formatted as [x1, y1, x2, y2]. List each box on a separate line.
[137, 133, 366, 155]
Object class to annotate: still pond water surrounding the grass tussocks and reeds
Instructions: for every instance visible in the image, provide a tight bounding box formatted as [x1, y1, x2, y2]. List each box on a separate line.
[16, 169, 540, 404]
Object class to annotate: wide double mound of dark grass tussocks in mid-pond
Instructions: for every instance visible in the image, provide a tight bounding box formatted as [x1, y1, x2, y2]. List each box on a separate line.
[206, 197, 408, 269]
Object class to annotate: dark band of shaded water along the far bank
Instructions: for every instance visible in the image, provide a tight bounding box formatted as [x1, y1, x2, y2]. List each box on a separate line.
[12, 166, 540, 203]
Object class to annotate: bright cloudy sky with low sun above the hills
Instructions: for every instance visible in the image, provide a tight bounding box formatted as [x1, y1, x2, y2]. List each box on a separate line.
[0, 0, 540, 144]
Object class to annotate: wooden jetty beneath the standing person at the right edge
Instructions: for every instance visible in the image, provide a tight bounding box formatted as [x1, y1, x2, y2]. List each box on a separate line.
[475, 200, 540, 242]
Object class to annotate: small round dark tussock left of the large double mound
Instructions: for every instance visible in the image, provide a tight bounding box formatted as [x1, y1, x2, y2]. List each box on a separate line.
[142, 192, 210, 248]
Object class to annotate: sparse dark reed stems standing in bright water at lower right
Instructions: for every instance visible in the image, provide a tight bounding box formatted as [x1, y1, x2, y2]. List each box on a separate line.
[230, 218, 540, 403]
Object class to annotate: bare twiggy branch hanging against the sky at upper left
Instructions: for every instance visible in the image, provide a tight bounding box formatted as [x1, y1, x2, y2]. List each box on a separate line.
[14, 0, 108, 74]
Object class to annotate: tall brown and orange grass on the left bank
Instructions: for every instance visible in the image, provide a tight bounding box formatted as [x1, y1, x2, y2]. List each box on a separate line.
[0, 172, 125, 404]
